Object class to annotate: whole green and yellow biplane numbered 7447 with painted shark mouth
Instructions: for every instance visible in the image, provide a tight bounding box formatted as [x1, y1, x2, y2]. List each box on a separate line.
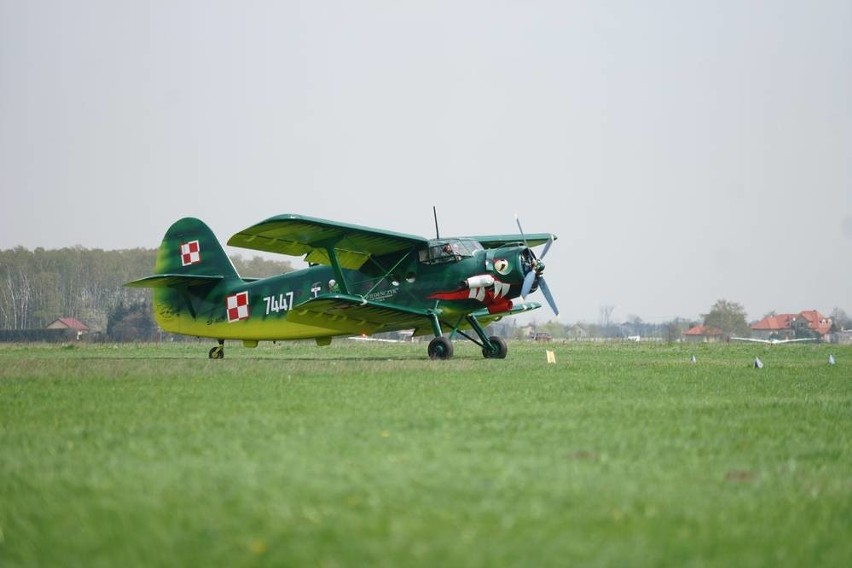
[126, 214, 558, 359]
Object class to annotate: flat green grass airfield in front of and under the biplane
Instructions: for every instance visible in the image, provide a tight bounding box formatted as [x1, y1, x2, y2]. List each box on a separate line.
[0, 341, 852, 567]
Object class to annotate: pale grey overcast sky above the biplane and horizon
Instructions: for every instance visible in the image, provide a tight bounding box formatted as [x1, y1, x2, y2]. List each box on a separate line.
[0, 0, 852, 322]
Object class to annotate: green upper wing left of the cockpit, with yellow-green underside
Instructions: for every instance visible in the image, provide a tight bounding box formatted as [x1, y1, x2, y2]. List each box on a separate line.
[228, 214, 428, 270]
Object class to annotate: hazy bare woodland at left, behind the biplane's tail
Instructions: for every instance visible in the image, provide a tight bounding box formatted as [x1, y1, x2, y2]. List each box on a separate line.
[0, 247, 293, 332]
